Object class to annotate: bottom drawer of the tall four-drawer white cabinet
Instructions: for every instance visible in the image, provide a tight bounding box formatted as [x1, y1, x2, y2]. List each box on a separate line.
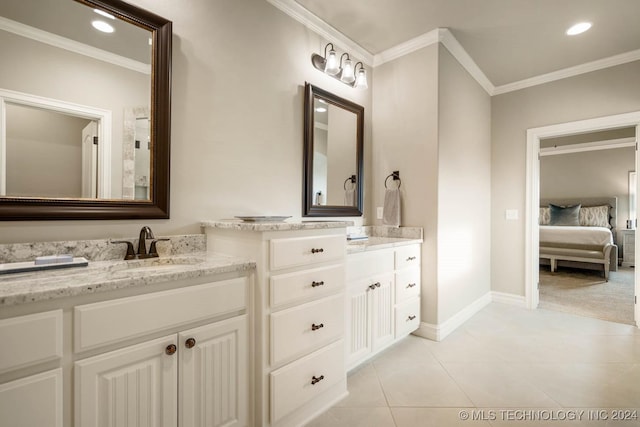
[270, 340, 346, 423]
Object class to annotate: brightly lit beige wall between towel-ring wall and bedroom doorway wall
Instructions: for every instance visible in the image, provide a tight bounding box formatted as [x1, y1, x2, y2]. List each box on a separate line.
[437, 47, 491, 324]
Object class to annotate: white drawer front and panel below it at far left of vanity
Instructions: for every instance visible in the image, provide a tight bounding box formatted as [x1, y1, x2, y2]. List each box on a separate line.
[0, 310, 63, 427]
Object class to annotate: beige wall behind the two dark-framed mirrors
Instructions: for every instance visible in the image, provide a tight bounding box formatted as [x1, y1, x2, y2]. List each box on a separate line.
[0, 0, 374, 243]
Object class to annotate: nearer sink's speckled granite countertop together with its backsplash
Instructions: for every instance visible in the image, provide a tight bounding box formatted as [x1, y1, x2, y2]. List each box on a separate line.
[0, 236, 255, 308]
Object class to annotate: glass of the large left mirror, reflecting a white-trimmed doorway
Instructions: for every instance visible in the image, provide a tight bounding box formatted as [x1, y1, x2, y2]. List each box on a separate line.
[0, 0, 153, 200]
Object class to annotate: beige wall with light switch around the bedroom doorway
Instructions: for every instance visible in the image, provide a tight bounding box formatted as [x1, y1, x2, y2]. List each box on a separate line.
[491, 61, 640, 295]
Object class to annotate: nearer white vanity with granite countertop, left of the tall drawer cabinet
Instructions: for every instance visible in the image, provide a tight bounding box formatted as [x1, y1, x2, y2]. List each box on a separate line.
[0, 237, 255, 427]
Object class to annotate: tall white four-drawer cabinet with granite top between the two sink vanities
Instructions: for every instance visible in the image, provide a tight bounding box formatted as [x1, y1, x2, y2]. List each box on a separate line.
[204, 223, 347, 427]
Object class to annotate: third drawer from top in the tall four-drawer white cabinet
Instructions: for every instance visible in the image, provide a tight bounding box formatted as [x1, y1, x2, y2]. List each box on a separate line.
[271, 293, 345, 364]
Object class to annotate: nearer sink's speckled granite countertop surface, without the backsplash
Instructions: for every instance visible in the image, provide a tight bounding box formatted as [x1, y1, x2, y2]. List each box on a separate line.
[0, 252, 256, 307]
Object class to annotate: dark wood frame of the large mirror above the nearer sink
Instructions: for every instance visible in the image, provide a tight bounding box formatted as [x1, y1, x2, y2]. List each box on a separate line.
[0, 0, 172, 221]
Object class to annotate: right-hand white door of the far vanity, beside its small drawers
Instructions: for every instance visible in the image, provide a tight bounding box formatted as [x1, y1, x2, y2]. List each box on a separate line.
[370, 274, 394, 351]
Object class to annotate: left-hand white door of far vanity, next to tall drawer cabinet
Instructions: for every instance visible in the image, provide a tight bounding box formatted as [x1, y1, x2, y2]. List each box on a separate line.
[345, 281, 372, 369]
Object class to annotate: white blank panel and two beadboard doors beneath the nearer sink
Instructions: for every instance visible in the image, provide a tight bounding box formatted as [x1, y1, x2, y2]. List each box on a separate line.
[74, 278, 249, 427]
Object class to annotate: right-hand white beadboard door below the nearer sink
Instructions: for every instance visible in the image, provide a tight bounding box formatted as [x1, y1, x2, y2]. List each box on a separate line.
[178, 315, 249, 427]
